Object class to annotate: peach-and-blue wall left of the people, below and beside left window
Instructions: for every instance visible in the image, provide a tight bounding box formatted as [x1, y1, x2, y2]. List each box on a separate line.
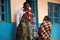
[0, 0, 25, 40]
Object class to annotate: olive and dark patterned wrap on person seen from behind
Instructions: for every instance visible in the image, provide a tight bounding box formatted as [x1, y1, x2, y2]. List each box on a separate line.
[16, 14, 32, 40]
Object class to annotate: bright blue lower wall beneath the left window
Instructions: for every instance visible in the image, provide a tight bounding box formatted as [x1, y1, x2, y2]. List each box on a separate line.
[0, 23, 16, 40]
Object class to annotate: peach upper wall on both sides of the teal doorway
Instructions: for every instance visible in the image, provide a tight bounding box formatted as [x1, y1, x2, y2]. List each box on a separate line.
[11, 0, 60, 23]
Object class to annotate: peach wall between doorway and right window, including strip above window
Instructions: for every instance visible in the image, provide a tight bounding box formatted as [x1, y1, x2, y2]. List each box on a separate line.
[38, 0, 60, 23]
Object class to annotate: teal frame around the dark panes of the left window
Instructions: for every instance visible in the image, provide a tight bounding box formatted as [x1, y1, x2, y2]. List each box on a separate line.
[0, 0, 11, 23]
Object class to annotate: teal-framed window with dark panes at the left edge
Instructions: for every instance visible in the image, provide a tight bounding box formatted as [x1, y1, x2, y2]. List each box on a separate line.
[0, 0, 11, 23]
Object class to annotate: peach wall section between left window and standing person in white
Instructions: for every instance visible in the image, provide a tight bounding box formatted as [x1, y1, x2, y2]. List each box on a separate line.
[11, 0, 26, 22]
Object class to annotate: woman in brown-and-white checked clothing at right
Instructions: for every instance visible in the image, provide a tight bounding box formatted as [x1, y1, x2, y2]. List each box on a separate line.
[38, 16, 51, 40]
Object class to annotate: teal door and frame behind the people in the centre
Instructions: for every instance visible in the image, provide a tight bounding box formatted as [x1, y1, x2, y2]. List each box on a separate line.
[26, 0, 38, 27]
